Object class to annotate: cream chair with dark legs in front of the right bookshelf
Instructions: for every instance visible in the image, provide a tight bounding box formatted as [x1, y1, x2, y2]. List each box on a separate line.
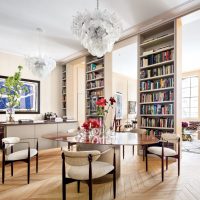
[146, 133, 180, 181]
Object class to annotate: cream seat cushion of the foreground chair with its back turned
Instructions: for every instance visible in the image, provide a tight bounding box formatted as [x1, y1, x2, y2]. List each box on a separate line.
[66, 161, 114, 180]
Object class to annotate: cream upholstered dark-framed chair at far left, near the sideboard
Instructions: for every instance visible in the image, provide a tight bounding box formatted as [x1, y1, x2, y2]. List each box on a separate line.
[2, 137, 38, 184]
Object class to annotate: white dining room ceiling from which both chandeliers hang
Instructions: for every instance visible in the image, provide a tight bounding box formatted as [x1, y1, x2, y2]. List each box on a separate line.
[0, 0, 195, 60]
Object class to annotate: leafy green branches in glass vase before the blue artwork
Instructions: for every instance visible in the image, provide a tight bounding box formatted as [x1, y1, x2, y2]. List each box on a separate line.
[0, 66, 28, 122]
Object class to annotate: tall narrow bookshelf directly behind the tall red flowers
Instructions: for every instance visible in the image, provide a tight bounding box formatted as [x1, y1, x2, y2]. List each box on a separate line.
[85, 55, 105, 119]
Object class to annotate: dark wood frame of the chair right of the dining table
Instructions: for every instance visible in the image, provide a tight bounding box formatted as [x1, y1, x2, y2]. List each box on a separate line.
[145, 138, 180, 182]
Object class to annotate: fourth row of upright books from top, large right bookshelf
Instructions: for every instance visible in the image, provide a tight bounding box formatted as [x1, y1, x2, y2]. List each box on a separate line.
[140, 90, 174, 103]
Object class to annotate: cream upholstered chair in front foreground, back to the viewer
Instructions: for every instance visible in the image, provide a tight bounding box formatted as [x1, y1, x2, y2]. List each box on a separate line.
[62, 149, 116, 200]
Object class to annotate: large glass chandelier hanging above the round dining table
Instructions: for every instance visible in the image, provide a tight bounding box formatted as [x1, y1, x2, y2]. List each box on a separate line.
[72, 0, 122, 57]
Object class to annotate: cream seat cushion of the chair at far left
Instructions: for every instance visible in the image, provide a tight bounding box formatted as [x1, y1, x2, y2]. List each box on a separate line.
[6, 149, 37, 160]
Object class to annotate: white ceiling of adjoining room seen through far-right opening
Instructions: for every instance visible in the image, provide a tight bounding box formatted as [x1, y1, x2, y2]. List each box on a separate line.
[182, 11, 200, 72]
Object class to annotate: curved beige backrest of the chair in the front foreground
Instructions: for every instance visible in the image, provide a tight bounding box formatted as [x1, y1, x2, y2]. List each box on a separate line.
[63, 150, 101, 166]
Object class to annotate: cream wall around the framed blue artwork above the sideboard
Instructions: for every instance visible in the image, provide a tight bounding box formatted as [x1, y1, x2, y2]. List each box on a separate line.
[0, 53, 62, 120]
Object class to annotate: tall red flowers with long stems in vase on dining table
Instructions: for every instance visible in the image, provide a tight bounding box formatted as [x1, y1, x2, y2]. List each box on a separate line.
[96, 97, 116, 135]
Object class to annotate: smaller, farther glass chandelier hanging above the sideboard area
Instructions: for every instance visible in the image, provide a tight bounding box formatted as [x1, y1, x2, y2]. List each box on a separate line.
[26, 28, 56, 78]
